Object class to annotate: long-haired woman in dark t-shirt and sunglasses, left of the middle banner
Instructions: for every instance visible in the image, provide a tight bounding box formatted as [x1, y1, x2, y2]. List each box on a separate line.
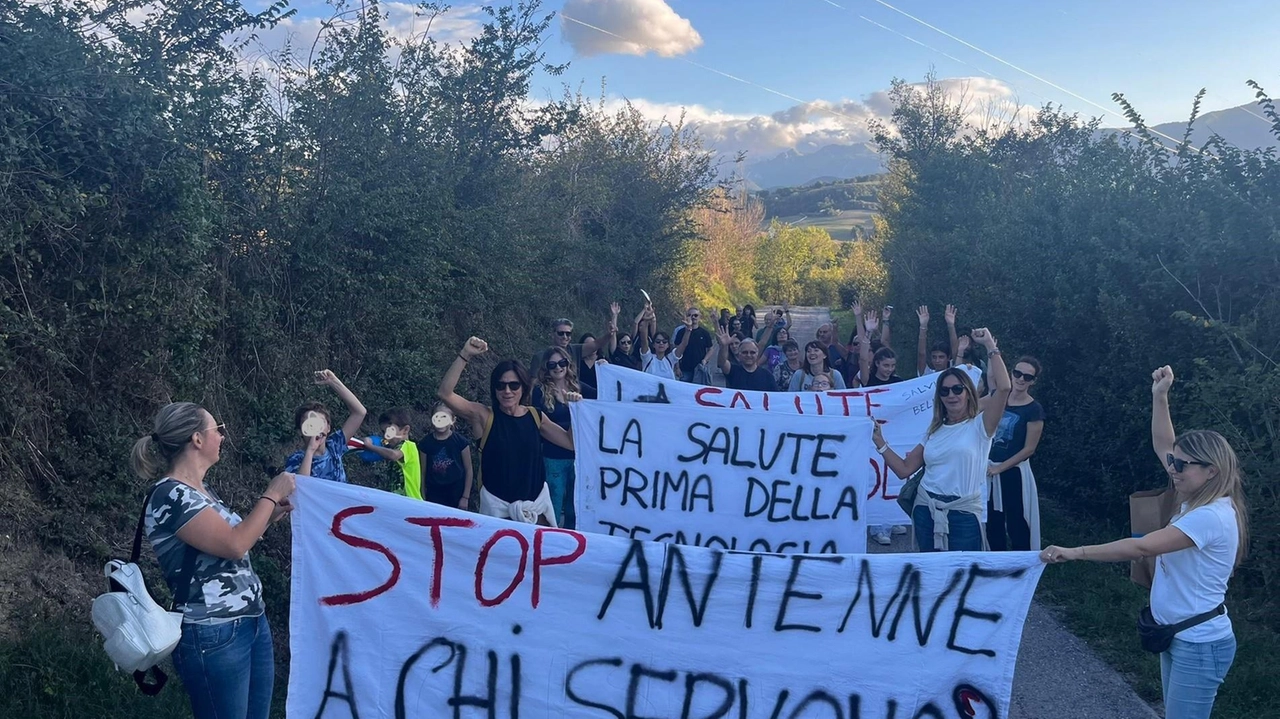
[531, 347, 595, 530]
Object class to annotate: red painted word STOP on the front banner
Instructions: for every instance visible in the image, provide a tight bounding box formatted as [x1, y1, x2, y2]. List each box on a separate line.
[320, 505, 586, 609]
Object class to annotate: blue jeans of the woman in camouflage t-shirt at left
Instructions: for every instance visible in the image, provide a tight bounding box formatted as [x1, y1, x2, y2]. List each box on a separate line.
[173, 614, 275, 719]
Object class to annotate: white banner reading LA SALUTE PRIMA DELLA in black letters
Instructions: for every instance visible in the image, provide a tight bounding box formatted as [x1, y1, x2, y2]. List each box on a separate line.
[570, 402, 876, 554]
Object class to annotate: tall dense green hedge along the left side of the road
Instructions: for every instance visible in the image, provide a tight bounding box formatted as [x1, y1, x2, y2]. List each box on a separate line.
[0, 0, 712, 701]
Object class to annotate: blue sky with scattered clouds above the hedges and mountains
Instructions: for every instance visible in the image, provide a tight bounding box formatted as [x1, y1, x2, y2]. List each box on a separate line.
[247, 0, 1280, 157]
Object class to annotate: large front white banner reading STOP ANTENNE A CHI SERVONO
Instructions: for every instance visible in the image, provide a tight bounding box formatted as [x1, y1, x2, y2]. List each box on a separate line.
[287, 477, 1042, 719]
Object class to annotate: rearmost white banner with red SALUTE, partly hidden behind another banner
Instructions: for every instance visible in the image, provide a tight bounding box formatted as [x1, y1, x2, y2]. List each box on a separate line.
[596, 365, 980, 525]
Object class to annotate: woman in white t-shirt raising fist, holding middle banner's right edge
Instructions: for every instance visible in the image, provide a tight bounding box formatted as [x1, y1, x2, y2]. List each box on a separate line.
[872, 328, 1012, 551]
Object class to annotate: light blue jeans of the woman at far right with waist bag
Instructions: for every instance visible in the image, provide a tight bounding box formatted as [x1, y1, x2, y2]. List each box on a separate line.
[1160, 636, 1235, 719]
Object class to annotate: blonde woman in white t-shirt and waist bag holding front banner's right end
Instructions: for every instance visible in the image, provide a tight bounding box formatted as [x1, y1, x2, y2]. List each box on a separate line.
[1041, 366, 1249, 719]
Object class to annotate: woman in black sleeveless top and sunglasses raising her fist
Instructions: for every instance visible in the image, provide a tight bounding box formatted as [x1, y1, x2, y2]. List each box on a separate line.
[436, 336, 573, 527]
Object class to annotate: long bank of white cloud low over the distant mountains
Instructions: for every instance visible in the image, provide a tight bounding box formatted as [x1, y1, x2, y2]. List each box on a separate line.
[609, 78, 1037, 160]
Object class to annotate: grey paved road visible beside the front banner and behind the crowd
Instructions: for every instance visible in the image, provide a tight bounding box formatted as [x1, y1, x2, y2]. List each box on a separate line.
[768, 307, 1160, 719]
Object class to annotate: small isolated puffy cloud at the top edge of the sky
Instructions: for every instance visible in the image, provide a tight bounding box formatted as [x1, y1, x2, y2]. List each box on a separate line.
[561, 0, 703, 58]
